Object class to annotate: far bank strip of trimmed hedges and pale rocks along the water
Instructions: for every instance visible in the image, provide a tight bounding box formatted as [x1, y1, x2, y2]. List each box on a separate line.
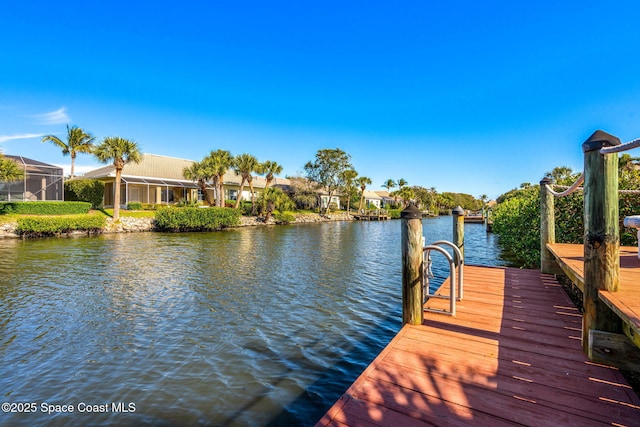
[0, 202, 353, 238]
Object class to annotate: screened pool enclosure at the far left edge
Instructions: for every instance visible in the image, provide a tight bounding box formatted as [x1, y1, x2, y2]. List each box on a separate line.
[0, 154, 64, 202]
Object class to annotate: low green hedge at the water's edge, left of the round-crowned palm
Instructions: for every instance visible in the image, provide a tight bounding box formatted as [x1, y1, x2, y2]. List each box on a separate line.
[16, 215, 106, 236]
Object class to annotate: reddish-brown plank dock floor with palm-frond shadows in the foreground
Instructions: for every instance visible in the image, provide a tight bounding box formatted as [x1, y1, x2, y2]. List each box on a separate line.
[317, 266, 640, 427]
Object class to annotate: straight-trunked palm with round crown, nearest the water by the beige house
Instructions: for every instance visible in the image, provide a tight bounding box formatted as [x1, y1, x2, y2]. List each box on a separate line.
[93, 136, 142, 221]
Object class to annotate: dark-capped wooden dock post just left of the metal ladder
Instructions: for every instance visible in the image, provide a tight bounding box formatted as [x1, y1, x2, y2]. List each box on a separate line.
[400, 202, 424, 325]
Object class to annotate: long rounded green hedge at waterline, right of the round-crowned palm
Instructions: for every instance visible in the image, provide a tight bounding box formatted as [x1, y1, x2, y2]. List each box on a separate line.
[155, 207, 240, 231]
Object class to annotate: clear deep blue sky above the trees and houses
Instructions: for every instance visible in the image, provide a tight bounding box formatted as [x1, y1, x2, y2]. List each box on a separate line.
[0, 0, 640, 197]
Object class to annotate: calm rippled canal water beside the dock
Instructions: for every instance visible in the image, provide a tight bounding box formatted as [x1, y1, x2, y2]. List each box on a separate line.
[0, 217, 502, 426]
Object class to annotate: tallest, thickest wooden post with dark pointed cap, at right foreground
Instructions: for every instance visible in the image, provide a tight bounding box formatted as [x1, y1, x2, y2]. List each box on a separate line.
[582, 130, 621, 354]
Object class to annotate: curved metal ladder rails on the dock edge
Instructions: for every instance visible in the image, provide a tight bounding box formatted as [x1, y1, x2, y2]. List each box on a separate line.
[422, 240, 464, 316]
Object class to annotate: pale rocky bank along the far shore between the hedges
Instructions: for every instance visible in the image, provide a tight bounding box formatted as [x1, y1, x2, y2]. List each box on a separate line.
[0, 213, 355, 238]
